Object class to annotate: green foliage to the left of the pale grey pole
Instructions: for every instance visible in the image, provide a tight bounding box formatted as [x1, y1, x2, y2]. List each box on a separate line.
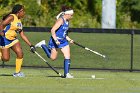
[1, 0, 101, 28]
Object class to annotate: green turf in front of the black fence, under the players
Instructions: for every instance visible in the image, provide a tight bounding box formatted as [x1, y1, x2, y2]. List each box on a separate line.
[0, 68, 140, 93]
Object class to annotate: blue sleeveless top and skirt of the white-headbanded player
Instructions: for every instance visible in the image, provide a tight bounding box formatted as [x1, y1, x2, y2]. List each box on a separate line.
[48, 17, 69, 48]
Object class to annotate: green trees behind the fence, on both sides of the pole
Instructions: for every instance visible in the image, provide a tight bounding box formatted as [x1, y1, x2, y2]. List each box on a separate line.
[0, 0, 140, 28]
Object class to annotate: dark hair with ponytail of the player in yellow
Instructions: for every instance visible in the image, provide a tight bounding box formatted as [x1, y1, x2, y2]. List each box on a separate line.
[2, 4, 23, 20]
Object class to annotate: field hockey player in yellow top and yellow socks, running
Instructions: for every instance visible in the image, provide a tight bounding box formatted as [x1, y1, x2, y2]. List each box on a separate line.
[0, 4, 35, 77]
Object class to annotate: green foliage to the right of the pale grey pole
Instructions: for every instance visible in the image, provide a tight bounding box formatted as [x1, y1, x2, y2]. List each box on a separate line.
[117, 0, 140, 28]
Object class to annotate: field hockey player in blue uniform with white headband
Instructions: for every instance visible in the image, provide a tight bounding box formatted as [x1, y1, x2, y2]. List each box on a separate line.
[35, 6, 74, 78]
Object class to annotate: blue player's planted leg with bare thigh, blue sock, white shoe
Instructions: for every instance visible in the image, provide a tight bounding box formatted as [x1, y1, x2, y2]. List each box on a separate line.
[61, 45, 73, 78]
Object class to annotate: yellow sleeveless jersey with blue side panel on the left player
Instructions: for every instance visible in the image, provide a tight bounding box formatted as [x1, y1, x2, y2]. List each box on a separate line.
[4, 14, 22, 40]
